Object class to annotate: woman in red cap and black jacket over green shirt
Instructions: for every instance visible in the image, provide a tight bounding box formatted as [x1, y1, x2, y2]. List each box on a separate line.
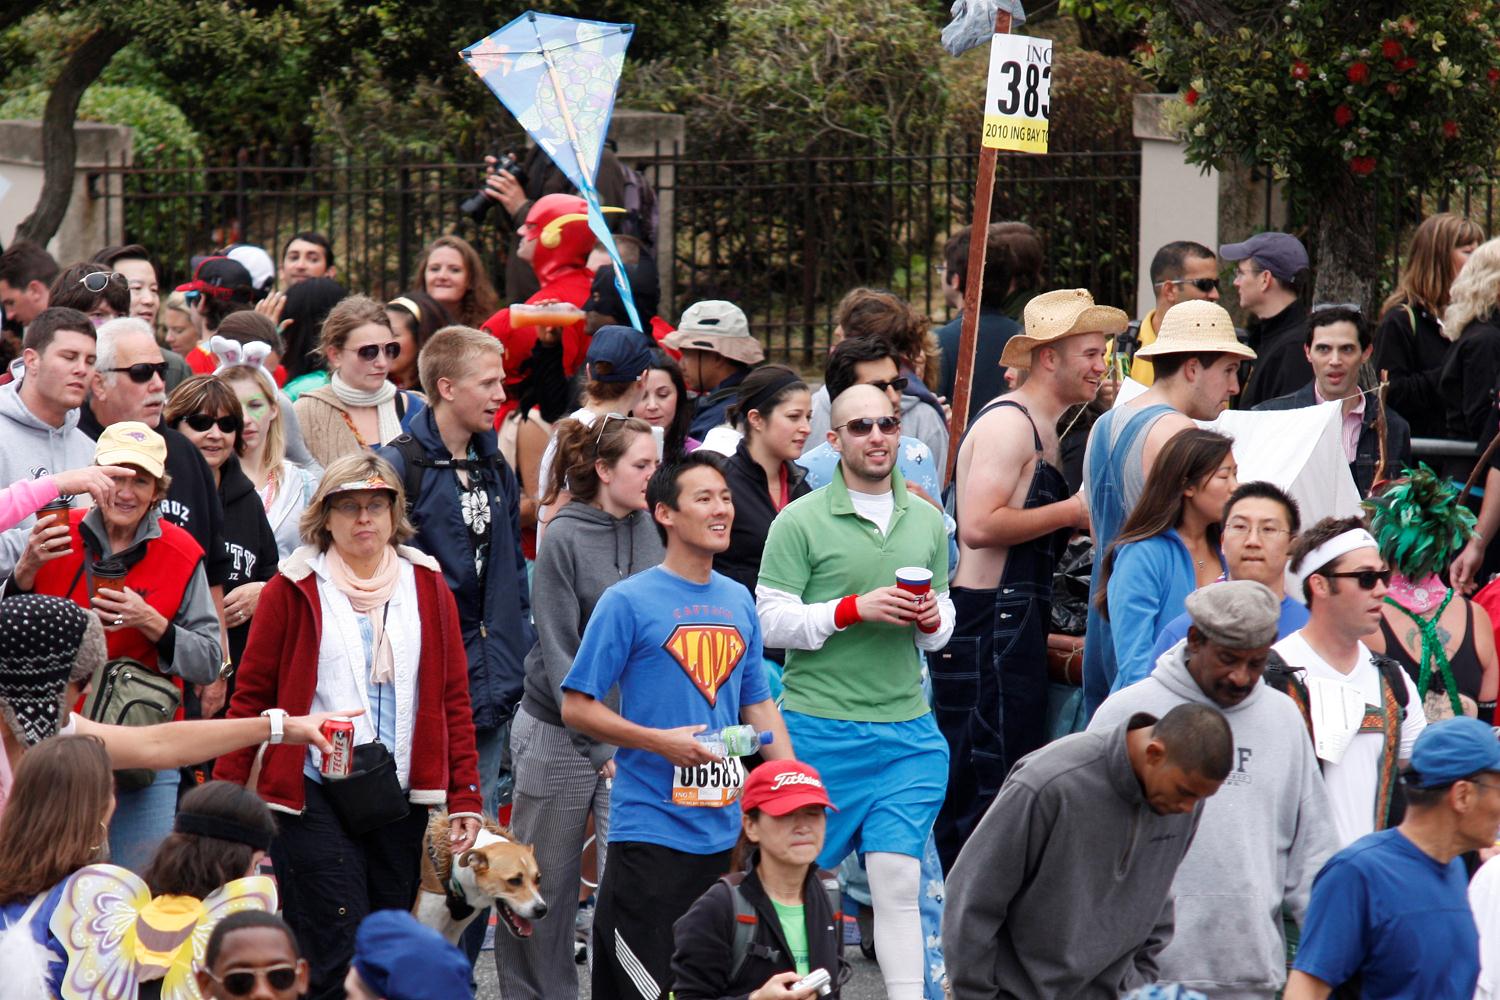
[672, 760, 849, 1000]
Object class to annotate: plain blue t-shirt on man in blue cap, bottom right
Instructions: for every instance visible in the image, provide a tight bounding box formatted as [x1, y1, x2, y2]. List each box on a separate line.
[1295, 829, 1479, 1000]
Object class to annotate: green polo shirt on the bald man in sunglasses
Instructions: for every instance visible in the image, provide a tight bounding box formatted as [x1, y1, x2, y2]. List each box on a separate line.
[758, 463, 948, 723]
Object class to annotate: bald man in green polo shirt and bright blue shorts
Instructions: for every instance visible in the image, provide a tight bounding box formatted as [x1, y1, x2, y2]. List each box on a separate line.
[756, 385, 954, 1000]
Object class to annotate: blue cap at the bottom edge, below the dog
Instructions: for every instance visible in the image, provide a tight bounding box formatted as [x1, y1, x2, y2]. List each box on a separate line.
[353, 910, 470, 1000]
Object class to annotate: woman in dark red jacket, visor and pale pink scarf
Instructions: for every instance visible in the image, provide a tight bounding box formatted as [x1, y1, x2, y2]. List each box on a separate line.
[215, 452, 483, 997]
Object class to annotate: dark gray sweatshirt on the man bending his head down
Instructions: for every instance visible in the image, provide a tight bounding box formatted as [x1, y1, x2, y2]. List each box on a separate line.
[942, 715, 1203, 1000]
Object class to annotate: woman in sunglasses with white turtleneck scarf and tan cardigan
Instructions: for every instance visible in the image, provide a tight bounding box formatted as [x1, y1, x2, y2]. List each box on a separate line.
[293, 295, 425, 466]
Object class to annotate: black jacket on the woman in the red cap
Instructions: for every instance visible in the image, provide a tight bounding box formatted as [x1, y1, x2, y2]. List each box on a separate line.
[672, 852, 846, 1000]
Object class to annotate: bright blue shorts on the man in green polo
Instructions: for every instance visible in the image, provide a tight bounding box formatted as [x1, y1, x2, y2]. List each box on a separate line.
[782, 712, 948, 868]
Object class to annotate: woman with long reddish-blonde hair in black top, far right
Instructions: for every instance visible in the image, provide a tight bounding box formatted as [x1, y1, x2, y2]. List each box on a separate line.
[1374, 211, 1485, 438]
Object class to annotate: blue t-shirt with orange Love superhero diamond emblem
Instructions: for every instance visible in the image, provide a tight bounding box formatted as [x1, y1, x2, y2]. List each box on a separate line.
[563, 567, 771, 855]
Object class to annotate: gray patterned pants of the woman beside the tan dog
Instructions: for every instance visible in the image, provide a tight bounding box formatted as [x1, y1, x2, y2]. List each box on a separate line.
[495, 709, 609, 1000]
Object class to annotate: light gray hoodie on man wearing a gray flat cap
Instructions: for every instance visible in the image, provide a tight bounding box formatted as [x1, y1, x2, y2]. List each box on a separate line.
[1089, 642, 1338, 1000]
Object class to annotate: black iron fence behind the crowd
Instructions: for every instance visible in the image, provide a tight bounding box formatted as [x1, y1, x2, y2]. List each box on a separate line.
[95, 142, 1140, 364]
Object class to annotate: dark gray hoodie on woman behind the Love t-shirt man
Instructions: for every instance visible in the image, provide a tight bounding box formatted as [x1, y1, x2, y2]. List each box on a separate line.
[521, 501, 666, 768]
